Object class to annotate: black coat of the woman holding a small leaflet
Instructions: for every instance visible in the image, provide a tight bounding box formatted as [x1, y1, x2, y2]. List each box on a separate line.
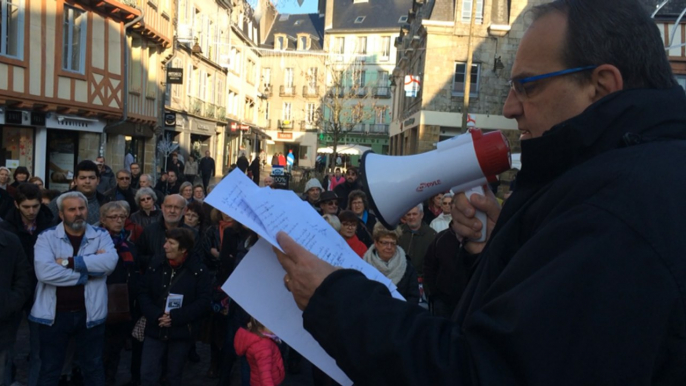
[138, 254, 211, 340]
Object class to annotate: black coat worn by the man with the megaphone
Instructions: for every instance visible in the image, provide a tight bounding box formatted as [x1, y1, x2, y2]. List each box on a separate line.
[303, 86, 686, 386]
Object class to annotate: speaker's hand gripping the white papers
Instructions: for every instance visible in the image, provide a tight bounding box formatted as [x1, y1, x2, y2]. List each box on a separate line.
[274, 232, 338, 310]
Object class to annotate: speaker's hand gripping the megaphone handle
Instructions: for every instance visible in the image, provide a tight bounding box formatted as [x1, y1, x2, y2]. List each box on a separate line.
[450, 186, 500, 254]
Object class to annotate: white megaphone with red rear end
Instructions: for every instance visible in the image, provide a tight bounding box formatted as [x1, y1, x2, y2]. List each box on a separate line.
[360, 129, 511, 241]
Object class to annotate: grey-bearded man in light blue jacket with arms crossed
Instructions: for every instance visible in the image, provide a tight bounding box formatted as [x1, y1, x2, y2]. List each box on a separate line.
[29, 192, 119, 385]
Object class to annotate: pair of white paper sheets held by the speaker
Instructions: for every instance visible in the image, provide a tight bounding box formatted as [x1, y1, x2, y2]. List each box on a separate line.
[205, 169, 403, 385]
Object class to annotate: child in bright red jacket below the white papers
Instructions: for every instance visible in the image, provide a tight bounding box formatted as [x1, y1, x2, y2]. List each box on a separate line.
[233, 318, 286, 386]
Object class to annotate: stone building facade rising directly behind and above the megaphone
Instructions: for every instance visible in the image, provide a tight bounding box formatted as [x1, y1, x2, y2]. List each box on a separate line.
[390, 0, 544, 155]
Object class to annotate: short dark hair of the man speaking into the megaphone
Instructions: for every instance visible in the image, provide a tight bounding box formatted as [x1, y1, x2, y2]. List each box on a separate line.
[532, 0, 677, 89]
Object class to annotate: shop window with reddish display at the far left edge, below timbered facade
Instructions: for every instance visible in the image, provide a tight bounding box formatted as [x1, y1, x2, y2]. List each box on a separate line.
[0, 126, 34, 175]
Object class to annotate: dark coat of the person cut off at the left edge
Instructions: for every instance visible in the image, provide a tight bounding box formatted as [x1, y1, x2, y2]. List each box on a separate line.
[0, 230, 33, 350]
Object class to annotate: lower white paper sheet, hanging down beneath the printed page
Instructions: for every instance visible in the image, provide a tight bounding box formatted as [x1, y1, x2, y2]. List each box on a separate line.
[222, 239, 353, 386]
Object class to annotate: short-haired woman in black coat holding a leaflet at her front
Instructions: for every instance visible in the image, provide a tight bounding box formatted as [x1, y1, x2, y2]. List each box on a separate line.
[138, 228, 211, 386]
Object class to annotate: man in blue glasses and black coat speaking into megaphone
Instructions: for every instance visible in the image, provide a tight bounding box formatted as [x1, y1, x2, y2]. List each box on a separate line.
[278, 0, 686, 386]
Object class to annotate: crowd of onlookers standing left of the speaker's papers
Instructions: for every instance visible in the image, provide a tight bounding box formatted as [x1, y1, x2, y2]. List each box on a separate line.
[0, 155, 287, 386]
